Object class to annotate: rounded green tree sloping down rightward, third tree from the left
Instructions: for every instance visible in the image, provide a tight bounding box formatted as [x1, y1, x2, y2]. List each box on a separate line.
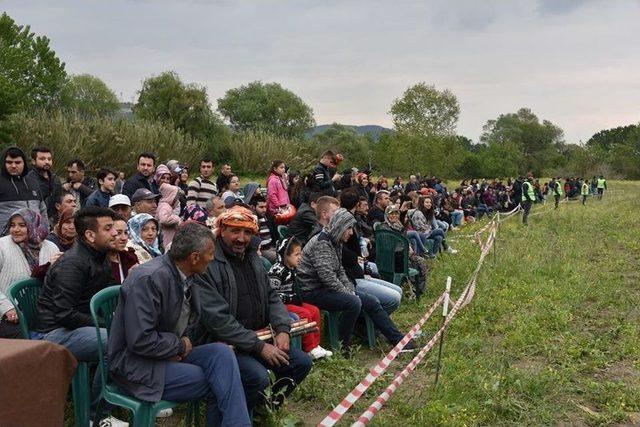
[133, 71, 225, 139]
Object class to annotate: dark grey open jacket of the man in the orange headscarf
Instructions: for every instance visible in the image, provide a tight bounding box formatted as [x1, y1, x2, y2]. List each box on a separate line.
[194, 243, 291, 353]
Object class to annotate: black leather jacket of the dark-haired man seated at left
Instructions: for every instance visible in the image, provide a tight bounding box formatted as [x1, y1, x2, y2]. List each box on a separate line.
[33, 240, 117, 332]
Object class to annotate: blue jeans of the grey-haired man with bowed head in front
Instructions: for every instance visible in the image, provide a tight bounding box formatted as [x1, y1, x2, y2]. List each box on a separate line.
[162, 343, 251, 426]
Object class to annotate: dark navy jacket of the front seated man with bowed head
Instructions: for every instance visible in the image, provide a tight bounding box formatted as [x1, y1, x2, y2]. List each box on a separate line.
[108, 255, 200, 402]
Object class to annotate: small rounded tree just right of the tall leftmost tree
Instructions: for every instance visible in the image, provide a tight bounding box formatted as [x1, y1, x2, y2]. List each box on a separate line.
[61, 74, 120, 117]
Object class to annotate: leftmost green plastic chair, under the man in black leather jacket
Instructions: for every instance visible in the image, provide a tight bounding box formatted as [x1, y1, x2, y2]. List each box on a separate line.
[7, 278, 91, 427]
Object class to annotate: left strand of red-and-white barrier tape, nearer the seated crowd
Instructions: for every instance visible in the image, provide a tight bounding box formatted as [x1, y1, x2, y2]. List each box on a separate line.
[318, 292, 446, 427]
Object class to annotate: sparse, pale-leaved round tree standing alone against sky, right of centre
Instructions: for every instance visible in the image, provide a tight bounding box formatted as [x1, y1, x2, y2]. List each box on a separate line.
[389, 82, 460, 136]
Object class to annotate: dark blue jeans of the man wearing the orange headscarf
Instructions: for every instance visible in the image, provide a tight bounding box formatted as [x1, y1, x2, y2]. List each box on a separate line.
[236, 348, 312, 412]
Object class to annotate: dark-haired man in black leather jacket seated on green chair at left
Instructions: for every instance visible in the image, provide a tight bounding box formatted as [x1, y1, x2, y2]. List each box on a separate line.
[31, 207, 118, 422]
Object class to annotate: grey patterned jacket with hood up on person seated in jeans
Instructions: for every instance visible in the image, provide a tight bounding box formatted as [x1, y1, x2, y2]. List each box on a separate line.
[298, 208, 356, 295]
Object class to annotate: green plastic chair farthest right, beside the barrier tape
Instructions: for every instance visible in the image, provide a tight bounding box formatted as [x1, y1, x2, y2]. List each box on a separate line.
[375, 229, 418, 286]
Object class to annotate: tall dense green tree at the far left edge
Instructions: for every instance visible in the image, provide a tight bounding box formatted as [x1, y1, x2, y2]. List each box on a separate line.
[0, 13, 67, 109]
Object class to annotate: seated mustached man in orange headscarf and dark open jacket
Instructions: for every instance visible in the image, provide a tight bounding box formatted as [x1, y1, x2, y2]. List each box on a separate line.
[198, 206, 311, 411]
